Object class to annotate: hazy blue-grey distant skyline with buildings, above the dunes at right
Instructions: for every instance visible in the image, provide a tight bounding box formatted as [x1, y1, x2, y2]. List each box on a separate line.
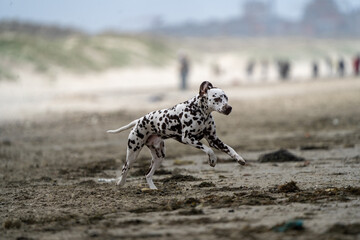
[150, 0, 360, 37]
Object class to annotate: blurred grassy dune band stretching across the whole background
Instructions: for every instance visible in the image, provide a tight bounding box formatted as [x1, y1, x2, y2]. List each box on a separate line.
[0, 32, 360, 80]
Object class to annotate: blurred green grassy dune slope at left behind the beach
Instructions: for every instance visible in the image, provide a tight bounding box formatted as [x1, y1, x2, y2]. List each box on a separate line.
[0, 34, 174, 80]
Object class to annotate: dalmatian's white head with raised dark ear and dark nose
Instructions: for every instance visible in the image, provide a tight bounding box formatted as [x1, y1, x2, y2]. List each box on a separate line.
[199, 81, 232, 115]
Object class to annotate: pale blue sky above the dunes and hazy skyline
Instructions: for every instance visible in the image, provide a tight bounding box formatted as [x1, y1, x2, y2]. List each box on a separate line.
[0, 0, 360, 33]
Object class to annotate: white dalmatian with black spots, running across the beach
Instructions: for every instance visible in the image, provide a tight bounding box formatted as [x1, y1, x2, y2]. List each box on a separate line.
[107, 81, 245, 189]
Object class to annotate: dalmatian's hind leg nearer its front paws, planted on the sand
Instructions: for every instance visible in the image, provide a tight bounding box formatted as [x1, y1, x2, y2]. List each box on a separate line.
[146, 135, 165, 189]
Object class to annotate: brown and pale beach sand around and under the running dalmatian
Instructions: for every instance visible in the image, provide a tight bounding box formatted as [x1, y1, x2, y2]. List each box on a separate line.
[0, 74, 360, 240]
